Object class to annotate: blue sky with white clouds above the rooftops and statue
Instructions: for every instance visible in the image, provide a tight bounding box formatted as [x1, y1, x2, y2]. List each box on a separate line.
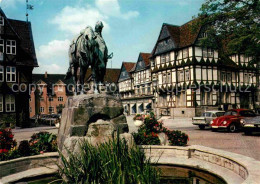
[0, 0, 204, 73]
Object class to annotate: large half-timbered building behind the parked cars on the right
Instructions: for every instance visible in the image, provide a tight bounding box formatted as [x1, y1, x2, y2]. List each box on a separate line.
[151, 21, 258, 117]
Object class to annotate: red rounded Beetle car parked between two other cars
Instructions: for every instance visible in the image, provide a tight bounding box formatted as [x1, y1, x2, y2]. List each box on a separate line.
[210, 109, 255, 132]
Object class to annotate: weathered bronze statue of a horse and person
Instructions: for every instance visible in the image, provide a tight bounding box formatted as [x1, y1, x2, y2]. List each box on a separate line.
[65, 21, 113, 95]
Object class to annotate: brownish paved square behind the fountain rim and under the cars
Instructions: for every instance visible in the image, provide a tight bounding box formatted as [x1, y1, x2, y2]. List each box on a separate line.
[13, 116, 260, 160]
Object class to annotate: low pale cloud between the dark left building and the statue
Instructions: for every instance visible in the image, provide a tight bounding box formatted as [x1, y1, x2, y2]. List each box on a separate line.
[34, 40, 70, 74]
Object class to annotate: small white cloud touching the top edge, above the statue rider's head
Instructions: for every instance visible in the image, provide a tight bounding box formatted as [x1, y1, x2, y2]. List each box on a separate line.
[96, 0, 139, 19]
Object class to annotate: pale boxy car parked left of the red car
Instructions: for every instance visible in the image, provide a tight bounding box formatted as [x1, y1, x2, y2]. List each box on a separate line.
[192, 111, 225, 130]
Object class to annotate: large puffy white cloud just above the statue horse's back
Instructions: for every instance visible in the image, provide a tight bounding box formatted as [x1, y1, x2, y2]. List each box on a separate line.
[51, 6, 109, 35]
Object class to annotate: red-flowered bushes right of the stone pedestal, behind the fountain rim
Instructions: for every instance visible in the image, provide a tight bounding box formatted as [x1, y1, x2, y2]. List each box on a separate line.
[132, 113, 189, 146]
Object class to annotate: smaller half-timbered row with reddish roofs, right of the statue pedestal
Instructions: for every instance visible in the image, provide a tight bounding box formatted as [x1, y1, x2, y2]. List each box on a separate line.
[118, 53, 154, 114]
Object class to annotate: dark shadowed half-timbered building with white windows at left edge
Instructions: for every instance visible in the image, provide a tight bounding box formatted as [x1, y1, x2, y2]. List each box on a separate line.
[0, 8, 38, 127]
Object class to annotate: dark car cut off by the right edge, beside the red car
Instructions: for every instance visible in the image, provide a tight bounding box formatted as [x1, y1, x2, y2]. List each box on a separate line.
[240, 115, 260, 135]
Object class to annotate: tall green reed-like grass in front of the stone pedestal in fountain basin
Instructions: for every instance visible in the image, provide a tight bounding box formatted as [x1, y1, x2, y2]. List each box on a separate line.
[60, 137, 160, 184]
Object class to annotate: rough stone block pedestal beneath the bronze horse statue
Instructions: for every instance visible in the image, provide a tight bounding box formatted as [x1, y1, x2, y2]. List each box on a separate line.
[58, 94, 129, 153]
